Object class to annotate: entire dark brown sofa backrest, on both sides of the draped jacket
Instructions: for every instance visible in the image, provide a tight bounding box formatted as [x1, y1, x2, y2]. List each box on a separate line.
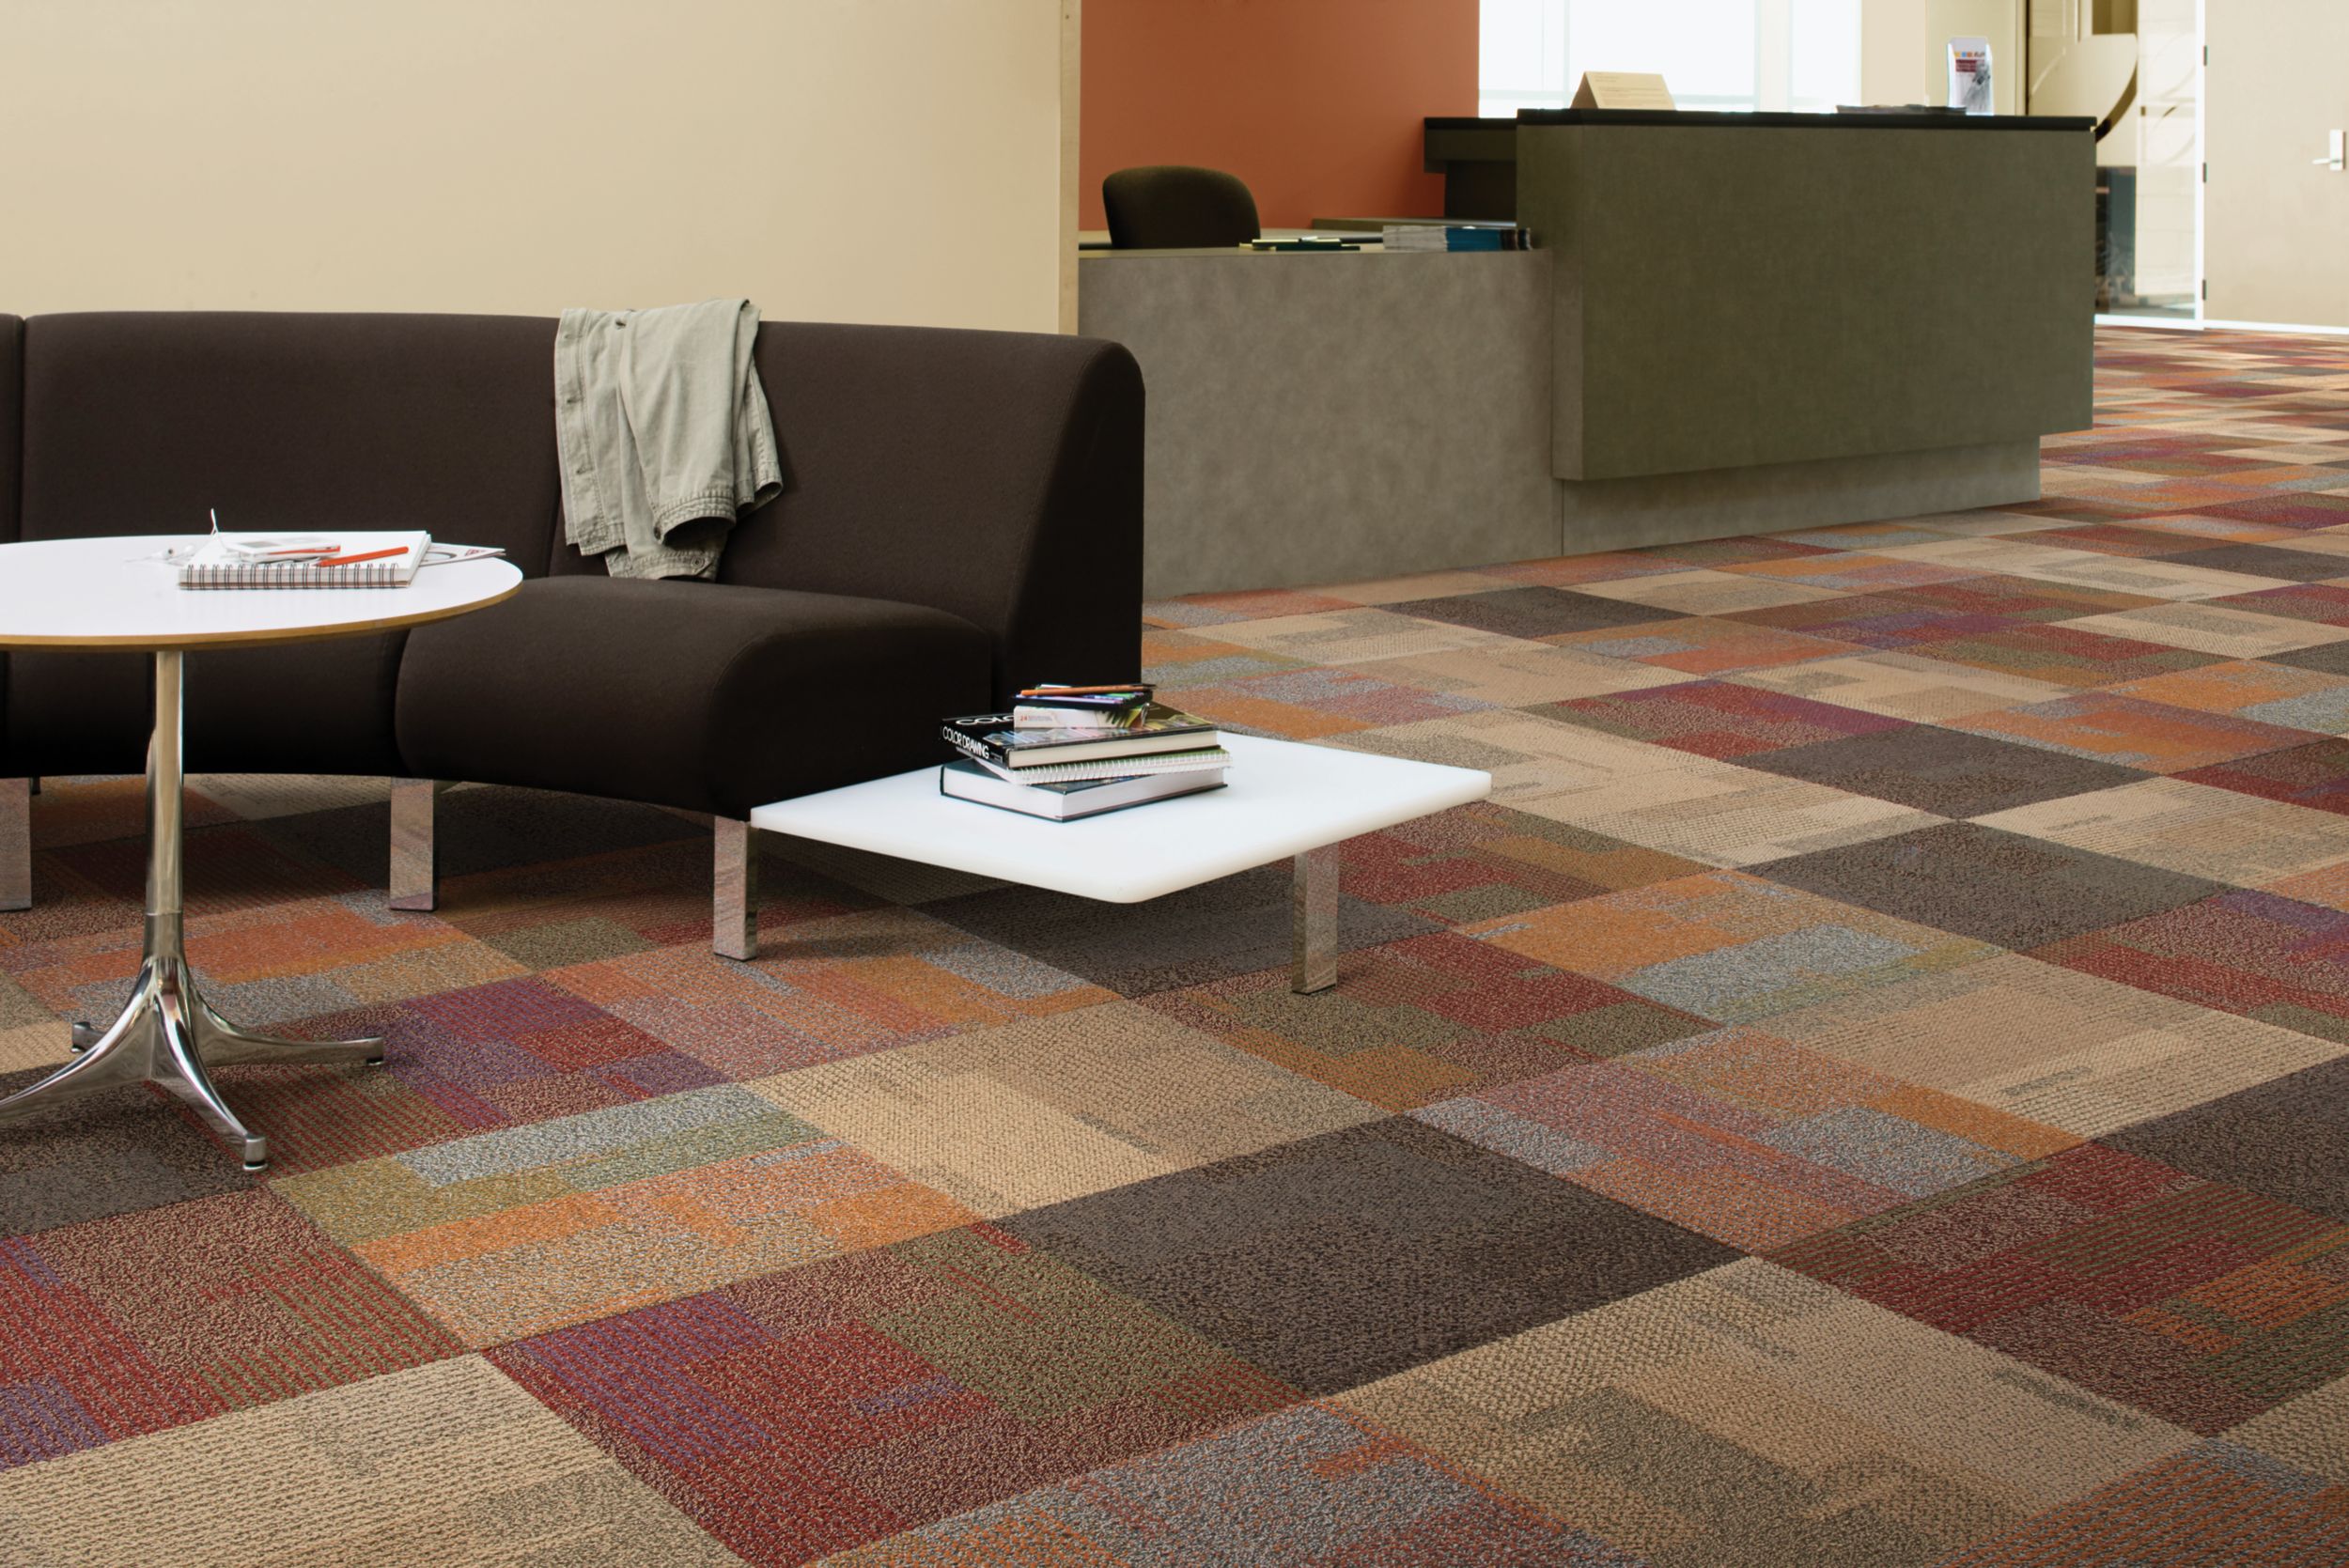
[0, 312, 1142, 688]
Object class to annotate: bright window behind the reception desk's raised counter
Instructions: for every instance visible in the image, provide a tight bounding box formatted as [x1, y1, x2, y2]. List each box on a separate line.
[1478, 0, 1860, 117]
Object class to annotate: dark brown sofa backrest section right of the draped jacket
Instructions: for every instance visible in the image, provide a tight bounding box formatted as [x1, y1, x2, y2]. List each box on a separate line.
[719, 321, 1142, 692]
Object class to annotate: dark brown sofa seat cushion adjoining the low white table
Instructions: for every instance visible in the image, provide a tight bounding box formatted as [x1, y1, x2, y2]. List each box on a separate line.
[397, 578, 991, 816]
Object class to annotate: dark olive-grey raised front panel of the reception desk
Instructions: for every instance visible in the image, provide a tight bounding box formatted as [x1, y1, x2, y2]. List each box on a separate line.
[1517, 115, 2095, 479]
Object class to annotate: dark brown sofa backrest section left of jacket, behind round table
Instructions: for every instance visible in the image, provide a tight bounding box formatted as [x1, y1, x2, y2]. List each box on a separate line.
[22, 312, 559, 575]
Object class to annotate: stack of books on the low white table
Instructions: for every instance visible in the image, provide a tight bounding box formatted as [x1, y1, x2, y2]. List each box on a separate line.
[938, 686, 1231, 821]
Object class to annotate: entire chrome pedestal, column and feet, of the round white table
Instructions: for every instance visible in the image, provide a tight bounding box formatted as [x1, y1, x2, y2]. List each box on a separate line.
[0, 650, 383, 1172]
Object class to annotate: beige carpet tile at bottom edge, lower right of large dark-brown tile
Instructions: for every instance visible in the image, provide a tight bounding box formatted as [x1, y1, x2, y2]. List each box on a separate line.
[1339, 1258, 2194, 1568]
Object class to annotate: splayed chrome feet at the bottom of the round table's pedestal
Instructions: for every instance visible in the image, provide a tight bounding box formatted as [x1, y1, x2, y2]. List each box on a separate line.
[0, 918, 383, 1172]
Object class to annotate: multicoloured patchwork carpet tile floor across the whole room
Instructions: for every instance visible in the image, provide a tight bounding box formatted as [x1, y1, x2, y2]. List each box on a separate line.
[0, 331, 2349, 1568]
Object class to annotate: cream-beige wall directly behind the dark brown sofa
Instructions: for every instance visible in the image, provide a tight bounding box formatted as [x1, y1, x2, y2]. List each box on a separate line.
[0, 0, 1074, 331]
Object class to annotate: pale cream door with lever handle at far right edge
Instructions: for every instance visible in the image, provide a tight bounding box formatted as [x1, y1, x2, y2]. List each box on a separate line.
[2203, 0, 2349, 326]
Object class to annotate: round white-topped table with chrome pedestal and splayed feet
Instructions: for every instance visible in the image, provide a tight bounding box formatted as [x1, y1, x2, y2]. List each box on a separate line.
[0, 536, 521, 1172]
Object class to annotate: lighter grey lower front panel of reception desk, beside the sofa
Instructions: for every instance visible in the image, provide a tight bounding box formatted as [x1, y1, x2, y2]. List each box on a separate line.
[1079, 251, 1558, 598]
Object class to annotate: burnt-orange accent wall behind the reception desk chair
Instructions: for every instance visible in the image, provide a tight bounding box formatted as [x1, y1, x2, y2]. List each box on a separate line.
[1079, 0, 1478, 227]
